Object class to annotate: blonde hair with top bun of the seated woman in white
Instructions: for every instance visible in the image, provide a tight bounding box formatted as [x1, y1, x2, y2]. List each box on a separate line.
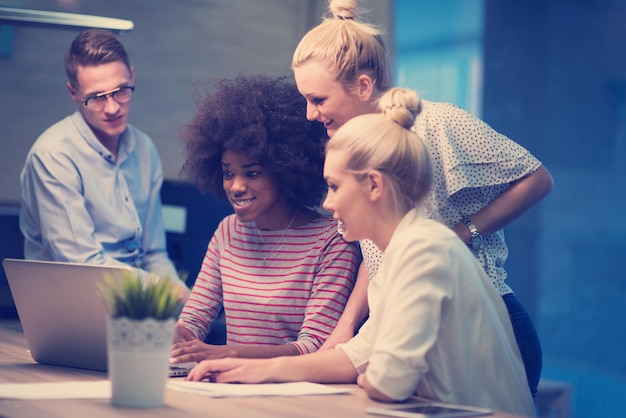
[326, 87, 433, 214]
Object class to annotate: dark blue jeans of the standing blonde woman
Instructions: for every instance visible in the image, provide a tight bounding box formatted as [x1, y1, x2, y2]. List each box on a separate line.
[502, 293, 542, 396]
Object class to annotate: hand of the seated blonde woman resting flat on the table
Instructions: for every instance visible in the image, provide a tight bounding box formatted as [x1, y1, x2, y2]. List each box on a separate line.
[185, 358, 276, 383]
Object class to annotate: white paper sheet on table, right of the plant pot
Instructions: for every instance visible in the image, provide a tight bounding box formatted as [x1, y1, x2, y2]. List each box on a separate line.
[167, 380, 350, 398]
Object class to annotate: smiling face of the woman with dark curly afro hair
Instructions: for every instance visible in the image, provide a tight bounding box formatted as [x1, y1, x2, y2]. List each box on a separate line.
[222, 150, 284, 229]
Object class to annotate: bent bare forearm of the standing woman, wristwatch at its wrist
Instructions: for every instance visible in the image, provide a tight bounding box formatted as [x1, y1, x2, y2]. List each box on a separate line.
[452, 166, 553, 243]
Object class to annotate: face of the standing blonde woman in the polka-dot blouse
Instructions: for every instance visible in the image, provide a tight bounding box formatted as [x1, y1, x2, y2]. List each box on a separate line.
[293, 59, 373, 137]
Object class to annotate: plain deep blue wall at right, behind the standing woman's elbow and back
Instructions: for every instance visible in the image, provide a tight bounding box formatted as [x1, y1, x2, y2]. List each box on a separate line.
[483, 0, 626, 417]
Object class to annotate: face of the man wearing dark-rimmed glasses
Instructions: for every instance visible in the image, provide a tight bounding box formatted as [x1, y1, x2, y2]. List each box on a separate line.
[67, 61, 135, 152]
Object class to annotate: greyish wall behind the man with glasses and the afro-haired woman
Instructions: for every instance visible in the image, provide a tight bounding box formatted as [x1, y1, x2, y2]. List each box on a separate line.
[0, 0, 392, 203]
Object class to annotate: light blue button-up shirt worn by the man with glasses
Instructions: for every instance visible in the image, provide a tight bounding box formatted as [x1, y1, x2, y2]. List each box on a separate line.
[20, 111, 179, 281]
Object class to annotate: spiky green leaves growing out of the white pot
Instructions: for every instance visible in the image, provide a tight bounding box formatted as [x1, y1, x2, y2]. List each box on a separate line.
[100, 271, 178, 320]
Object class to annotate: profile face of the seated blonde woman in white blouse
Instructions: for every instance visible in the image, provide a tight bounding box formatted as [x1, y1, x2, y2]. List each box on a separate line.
[323, 150, 372, 241]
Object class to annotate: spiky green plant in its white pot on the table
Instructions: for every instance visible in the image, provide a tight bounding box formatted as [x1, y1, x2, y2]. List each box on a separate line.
[100, 270, 178, 407]
